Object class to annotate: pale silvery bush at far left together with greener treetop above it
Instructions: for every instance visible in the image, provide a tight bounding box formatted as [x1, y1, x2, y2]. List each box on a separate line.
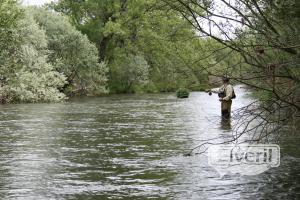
[0, 1, 66, 102]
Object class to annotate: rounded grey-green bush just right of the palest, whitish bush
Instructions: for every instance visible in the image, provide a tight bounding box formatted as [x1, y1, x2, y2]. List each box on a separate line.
[30, 8, 108, 95]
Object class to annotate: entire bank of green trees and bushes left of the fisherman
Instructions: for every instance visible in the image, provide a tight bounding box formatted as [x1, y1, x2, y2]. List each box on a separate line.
[0, 0, 212, 103]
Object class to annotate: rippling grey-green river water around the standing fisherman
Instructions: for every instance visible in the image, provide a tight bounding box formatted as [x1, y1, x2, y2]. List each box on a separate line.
[0, 86, 300, 200]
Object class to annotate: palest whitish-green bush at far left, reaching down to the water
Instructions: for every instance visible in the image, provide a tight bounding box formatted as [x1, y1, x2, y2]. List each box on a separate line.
[0, 9, 65, 102]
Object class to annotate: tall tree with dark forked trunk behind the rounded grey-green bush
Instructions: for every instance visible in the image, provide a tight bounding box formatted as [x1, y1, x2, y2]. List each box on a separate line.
[54, 0, 120, 62]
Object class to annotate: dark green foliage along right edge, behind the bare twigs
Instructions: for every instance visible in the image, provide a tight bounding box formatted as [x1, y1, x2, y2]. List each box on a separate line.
[240, 0, 300, 105]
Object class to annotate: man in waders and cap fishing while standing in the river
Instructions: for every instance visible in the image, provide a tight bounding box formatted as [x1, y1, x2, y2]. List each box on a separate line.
[208, 78, 235, 119]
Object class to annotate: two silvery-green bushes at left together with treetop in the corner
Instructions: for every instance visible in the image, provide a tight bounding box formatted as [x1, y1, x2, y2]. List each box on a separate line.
[0, 0, 107, 103]
